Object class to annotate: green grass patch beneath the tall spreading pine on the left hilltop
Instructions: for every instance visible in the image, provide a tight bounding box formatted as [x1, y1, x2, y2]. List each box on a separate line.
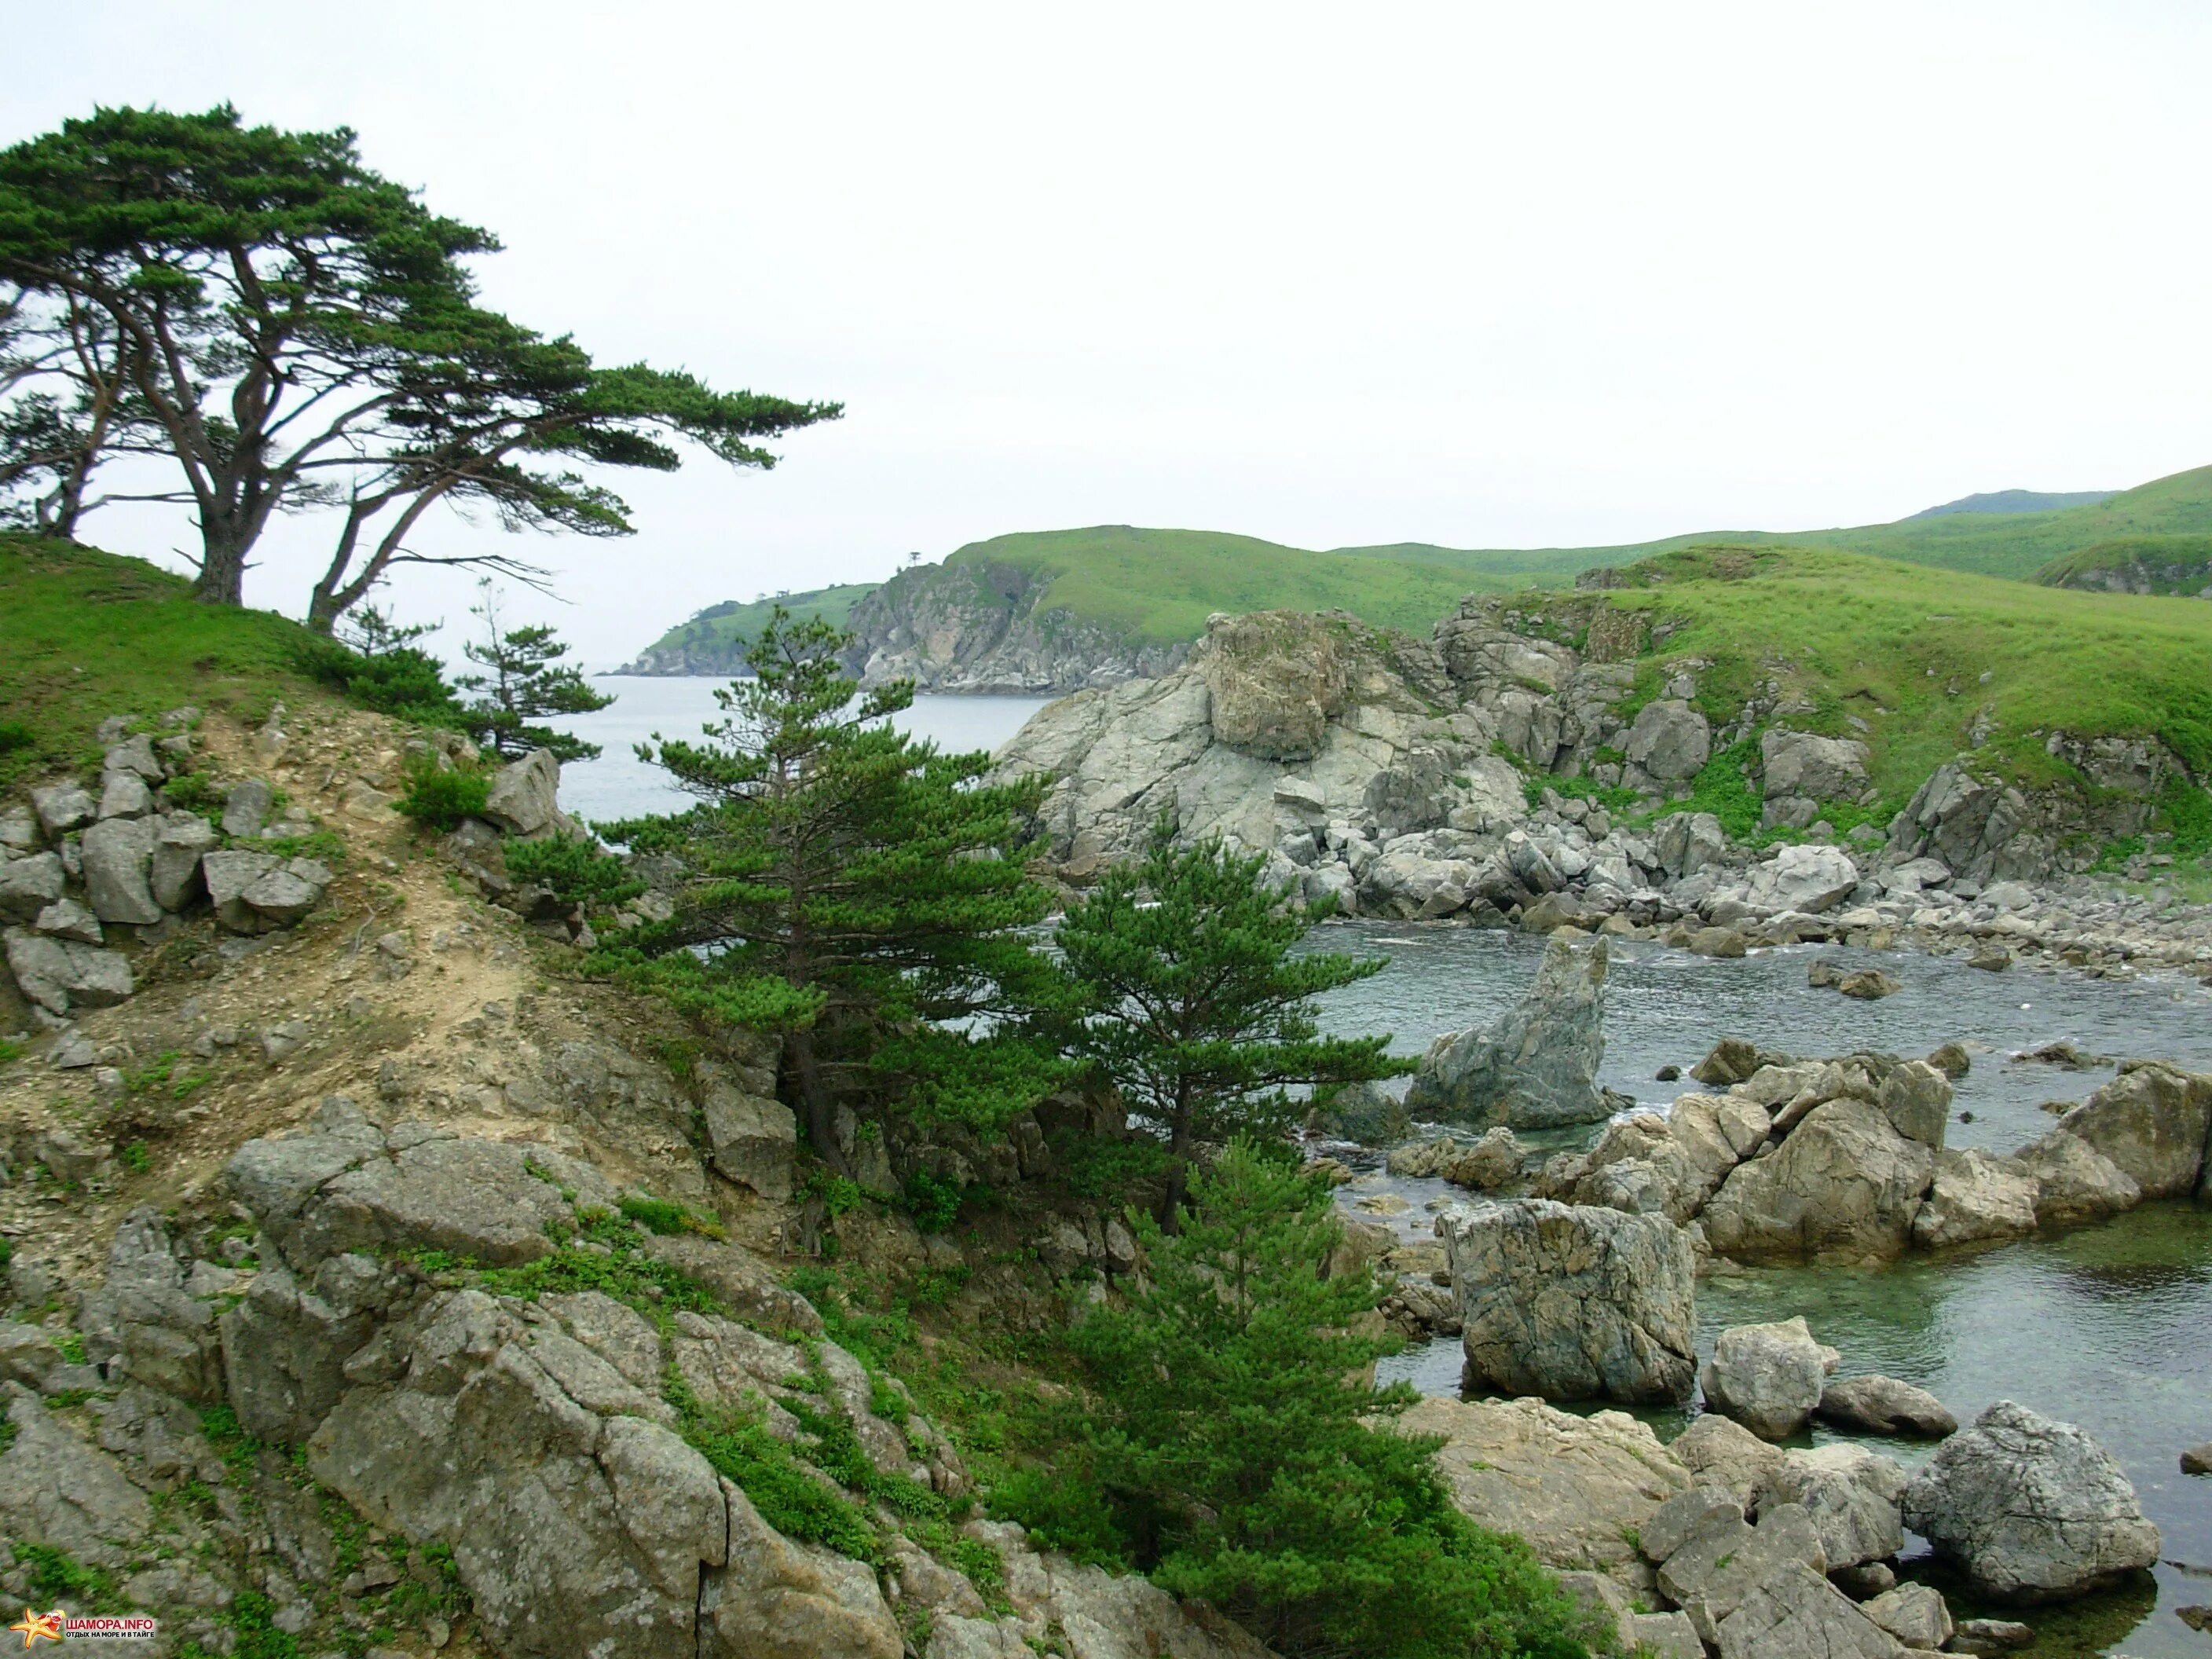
[0, 533, 342, 786]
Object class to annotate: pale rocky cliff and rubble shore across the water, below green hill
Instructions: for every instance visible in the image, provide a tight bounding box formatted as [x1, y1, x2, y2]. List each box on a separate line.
[1000, 599, 2212, 971]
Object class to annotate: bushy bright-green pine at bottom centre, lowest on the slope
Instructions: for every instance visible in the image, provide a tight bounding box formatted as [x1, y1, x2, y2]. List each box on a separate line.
[1062, 1139, 1586, 1659]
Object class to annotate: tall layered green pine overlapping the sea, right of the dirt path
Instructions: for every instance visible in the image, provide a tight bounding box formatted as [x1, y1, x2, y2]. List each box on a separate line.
[602, 606, 1066, 1172]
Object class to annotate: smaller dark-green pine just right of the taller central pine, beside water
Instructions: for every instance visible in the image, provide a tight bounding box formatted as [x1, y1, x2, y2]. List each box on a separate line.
[1057, 819, 1412, 1228]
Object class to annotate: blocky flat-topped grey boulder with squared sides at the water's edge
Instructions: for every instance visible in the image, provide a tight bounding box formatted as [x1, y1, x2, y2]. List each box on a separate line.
[1437, 1199, 1697, 1404]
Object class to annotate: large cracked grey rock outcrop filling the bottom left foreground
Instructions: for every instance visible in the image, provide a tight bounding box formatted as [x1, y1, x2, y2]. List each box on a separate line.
[0, 1097, 1268, 1659]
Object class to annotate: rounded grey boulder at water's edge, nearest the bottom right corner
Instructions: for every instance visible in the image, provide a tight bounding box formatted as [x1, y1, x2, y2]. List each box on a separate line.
[1905, 1401, 2159, 1602]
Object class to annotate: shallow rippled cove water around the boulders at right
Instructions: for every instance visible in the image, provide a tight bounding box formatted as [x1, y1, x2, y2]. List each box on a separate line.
[1317, 922, 2212, 1659]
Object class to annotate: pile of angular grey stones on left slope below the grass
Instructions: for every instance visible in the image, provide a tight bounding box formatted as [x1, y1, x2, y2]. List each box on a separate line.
[0, 708, 331, 1022]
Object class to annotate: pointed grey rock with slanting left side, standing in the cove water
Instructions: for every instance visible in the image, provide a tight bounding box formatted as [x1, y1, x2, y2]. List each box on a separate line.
[1404, 936, 1613, 1128]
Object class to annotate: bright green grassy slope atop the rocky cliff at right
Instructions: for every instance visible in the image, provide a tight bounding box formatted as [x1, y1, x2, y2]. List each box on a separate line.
[1606, 547, 2212, 805]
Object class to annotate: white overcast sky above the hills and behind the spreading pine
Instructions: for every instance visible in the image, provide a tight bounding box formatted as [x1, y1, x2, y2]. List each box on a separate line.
[13, 0, 2212, 666]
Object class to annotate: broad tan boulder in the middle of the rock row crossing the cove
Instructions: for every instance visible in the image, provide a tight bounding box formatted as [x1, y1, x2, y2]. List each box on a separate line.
[1701, 1097, 1936, 1261]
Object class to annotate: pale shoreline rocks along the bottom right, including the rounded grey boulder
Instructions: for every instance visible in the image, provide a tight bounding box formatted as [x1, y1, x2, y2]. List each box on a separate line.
[1401, 1380, 2159, 1659]
